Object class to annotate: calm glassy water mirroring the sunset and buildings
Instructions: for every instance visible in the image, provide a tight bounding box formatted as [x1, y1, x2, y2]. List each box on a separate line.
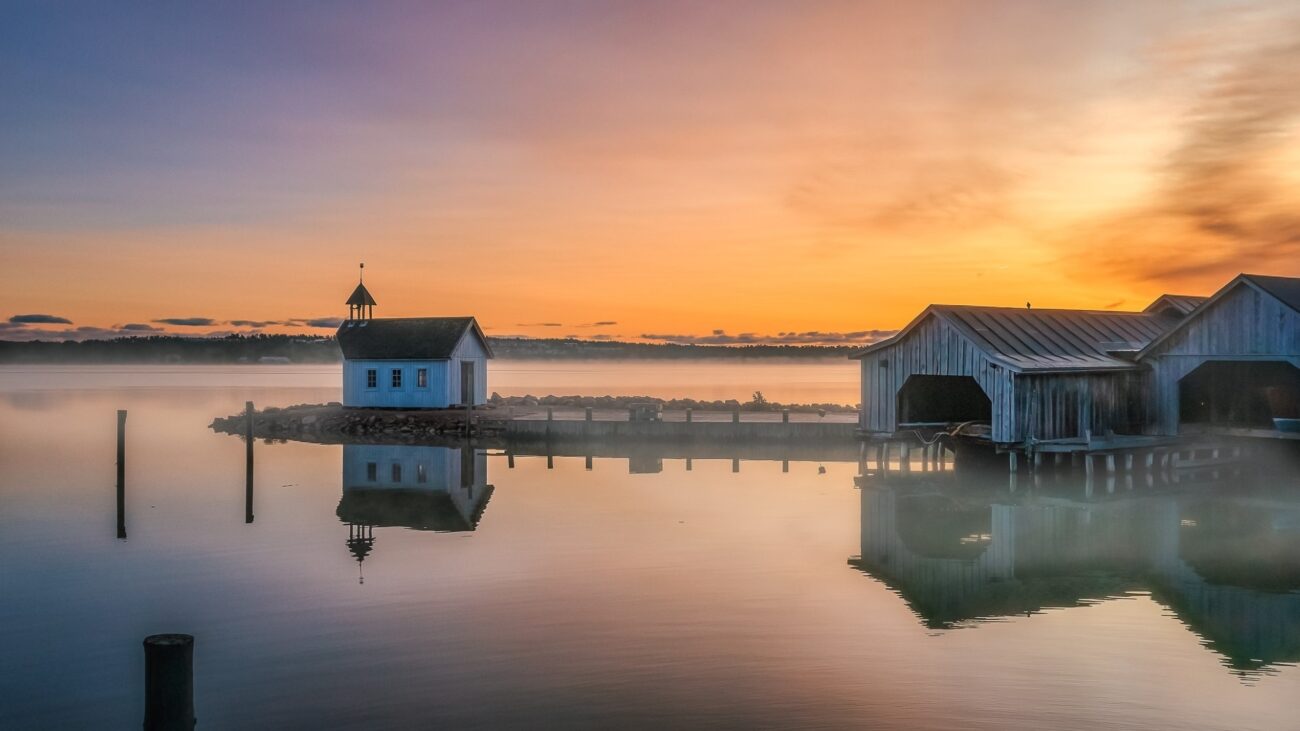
[0, 363, 1300, 730]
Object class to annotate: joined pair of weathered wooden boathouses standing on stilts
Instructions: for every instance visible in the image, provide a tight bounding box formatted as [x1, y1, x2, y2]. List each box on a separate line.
[853, 274, 1300, 451]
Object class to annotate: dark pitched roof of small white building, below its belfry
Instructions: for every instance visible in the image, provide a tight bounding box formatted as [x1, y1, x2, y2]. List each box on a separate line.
[335, 317, 493, 360]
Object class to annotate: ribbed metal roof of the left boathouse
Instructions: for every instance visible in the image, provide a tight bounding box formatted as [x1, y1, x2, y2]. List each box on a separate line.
[853, 304, 1174, 372]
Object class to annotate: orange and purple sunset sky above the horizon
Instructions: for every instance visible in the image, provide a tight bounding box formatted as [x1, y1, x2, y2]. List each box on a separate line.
[0, 0, 1300, 342]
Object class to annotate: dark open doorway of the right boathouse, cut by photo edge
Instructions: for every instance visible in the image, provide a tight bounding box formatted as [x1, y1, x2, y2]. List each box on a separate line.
[1178, 360, 1300, 429]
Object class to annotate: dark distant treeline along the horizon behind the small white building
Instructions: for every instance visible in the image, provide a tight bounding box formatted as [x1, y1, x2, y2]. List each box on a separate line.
[0, 334, 855, 364]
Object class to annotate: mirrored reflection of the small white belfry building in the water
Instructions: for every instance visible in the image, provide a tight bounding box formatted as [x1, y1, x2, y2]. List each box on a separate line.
[335, 444, 493, 580]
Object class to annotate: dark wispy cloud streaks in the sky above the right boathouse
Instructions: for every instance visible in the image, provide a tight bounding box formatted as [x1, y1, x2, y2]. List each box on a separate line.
[1065, 10, 1300, 286]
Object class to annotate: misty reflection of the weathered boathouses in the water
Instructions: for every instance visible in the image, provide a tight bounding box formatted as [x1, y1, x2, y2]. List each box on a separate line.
[850, 473, 1300, 670]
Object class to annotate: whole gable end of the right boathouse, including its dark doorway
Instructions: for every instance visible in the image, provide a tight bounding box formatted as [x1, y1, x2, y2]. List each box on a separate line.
[1138, 274, 1300, 436]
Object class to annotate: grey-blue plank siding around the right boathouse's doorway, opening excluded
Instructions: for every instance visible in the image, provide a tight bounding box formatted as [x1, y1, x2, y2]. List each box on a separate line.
[1144, 284, 1300, 434]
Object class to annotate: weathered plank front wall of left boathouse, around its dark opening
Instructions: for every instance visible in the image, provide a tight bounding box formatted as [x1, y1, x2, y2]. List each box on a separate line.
[862, 316, 1019, 442]
